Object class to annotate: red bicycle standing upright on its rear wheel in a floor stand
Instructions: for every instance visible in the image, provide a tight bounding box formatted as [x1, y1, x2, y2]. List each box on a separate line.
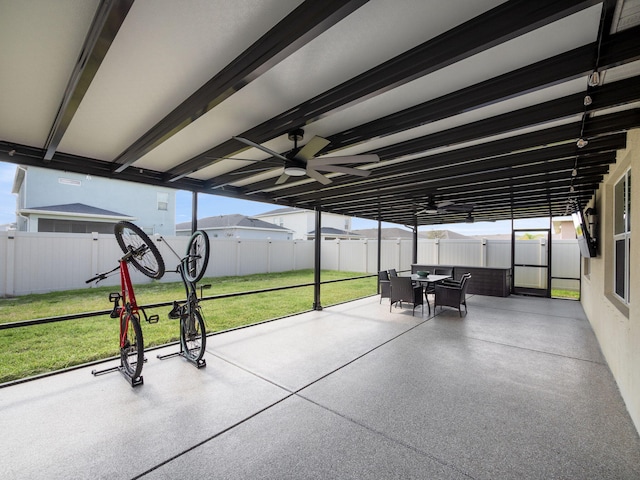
[86, 221, 164, 387]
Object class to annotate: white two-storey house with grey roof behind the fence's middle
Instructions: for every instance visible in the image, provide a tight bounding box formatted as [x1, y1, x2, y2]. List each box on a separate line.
[254, 207, 361, 240]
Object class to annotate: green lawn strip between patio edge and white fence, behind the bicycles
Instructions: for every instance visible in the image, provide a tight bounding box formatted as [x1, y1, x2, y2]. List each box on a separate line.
[0, 270, 376, 383]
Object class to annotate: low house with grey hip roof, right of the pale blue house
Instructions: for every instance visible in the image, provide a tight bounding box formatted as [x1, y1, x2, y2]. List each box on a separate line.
[176, 214, 293, 240]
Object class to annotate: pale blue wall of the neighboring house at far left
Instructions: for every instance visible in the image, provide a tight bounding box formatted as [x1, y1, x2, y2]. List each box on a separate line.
[14, 167, 176, 235]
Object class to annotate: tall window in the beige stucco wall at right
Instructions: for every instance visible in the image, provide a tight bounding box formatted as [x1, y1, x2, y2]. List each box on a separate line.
[613, 170, 631, 303]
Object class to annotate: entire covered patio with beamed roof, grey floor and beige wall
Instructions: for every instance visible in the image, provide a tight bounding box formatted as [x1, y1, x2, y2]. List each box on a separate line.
[0, 0, 640, 479]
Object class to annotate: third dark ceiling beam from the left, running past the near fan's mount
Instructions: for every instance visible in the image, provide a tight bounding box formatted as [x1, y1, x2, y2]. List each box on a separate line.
[166, 0, 599, 182]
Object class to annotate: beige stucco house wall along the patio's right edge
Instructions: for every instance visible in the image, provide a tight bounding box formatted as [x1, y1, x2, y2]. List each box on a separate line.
[581, 129, 640, 432]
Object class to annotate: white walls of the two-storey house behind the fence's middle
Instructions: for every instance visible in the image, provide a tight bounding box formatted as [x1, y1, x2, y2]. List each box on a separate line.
[254, 208, 351, 240]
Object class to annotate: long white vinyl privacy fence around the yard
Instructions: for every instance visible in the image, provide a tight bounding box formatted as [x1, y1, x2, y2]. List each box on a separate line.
[0, 231, 580, 297]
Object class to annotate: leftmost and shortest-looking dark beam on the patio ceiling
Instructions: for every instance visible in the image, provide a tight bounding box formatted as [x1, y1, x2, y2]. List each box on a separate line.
[44, 0, 134, 162]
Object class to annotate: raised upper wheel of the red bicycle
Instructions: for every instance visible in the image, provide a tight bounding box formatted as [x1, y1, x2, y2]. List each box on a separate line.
[114, 221, 164, 279]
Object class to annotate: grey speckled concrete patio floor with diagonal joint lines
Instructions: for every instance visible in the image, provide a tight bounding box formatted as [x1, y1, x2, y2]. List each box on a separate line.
[0, 296, 640, 480]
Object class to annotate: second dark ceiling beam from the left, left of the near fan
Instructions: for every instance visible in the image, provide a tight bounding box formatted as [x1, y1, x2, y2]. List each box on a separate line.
[114, 0, 368, 173]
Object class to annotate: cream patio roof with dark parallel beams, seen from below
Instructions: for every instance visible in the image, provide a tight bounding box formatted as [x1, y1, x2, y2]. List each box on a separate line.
[0, 0, 640, 225]
